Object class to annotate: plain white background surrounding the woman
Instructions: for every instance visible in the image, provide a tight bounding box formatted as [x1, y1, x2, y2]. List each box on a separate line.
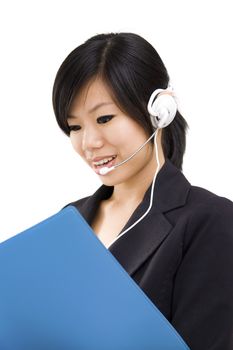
[0, 0, 233, 241]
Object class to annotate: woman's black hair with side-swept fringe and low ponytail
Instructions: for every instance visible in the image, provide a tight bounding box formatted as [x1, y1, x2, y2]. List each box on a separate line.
[53, 33, 188, 169]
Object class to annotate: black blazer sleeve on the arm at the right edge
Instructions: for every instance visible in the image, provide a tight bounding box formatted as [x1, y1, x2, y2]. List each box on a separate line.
[171, 198, 233, 350]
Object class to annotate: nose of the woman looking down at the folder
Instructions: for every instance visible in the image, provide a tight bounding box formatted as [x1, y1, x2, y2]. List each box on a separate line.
[82, 126, 104, 152]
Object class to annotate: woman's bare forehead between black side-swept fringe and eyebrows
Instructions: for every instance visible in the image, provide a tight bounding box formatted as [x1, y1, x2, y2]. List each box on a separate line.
[69, 79, 115, 115]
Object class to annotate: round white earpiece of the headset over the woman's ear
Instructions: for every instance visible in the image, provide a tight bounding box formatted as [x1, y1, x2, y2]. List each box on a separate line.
[147, 89, 177, 129]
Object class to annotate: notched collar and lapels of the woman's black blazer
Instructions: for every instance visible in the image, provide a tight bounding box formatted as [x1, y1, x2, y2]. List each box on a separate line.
[79, 159, 191, 275]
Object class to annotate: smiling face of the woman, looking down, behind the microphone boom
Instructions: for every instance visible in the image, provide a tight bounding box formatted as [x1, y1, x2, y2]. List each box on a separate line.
[67, 79, 155, 186]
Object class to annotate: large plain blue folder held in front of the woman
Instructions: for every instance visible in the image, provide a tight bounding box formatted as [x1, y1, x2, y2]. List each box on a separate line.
[0, 206, 189, 350]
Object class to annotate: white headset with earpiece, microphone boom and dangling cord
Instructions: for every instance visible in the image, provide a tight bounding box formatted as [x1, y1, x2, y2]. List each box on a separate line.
[99, 85, 178, 248]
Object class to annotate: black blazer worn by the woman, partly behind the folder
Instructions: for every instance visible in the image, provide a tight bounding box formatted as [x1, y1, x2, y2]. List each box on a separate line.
[70, 160, 233, 350]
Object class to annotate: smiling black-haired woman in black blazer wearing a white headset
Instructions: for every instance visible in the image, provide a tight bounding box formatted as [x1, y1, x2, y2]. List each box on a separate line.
[53, 33, 233, 350]
